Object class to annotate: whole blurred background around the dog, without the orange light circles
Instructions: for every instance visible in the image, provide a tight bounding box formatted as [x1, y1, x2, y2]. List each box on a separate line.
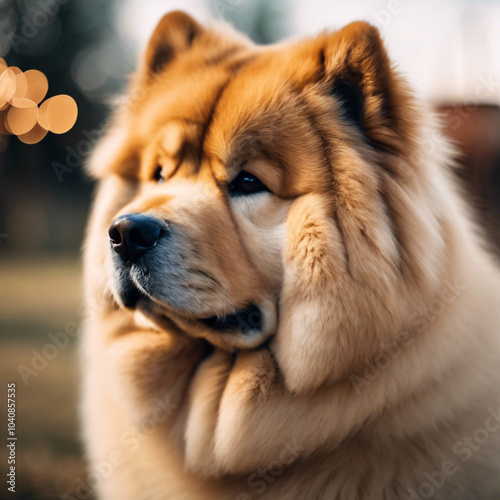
[0, 0, 500, 499]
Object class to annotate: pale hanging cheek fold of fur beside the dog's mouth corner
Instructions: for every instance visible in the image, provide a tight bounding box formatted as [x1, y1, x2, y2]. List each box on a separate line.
[273, 195, 350, 392]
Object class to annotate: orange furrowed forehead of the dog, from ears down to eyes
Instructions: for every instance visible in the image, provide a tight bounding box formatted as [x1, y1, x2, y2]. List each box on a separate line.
[129, 37, 332, 195]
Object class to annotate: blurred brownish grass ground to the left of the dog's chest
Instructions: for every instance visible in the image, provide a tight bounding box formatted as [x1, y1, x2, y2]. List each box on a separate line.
[0, 256, 84, 500]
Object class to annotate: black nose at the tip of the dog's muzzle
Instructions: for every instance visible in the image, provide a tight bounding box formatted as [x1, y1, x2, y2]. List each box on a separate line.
[108, 214, 161, 262]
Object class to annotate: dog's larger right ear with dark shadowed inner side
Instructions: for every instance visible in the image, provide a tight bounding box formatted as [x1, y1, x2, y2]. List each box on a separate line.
[320, 22, 412, 151]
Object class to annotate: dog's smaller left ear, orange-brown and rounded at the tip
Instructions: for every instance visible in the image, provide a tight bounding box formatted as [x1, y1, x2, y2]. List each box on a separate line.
[143, 10, 204, 75]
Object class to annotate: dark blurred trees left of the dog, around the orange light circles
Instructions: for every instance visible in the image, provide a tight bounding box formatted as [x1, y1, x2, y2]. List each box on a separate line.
[0, 0, 135, 252]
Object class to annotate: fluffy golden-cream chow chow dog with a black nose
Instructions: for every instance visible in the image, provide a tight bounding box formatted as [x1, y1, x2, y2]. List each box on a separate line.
[82, 12, 500, 500]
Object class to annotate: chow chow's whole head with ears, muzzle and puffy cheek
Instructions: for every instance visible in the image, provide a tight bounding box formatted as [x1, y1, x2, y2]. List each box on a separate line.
[91, 12, 446, 392]
